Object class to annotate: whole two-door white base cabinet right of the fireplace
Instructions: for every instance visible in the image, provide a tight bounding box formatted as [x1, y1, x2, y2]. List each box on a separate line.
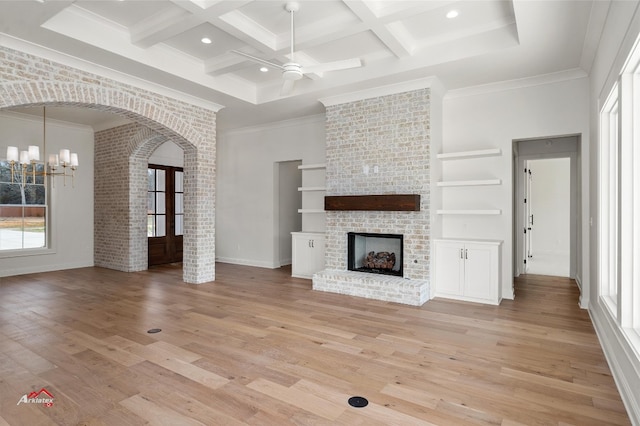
[433, 239, 502, 305]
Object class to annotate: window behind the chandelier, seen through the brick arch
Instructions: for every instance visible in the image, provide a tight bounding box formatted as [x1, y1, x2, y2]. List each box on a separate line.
[0, 161, 47, 250]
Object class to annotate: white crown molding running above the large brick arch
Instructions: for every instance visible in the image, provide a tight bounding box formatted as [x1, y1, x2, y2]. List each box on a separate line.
[0, 33, 224, 112]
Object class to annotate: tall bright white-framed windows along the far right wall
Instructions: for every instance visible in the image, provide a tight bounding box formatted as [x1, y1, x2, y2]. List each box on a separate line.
[598, 34, 640, 342]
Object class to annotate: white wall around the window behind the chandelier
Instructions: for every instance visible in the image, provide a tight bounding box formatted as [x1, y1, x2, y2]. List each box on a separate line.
[0, 111, 94, 277]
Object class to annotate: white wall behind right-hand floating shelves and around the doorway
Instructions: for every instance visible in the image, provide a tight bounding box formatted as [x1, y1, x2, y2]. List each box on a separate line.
[442, 73, 589, 298]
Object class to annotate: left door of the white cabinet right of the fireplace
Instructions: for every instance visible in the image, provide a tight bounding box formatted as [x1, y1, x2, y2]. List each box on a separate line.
[435, 241, 464, 295]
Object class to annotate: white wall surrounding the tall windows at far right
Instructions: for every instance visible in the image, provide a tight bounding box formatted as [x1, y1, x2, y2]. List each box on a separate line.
[585, 1, 640, 425]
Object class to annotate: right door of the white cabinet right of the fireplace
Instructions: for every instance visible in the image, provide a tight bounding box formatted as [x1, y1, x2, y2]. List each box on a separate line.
[464, 243, 498, 301]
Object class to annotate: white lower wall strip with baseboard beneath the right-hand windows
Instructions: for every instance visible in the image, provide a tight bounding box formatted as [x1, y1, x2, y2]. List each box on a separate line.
[589, 304, 640, 425]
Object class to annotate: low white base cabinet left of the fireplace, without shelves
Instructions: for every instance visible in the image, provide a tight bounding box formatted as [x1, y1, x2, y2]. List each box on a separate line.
[291, 232, 325, 278]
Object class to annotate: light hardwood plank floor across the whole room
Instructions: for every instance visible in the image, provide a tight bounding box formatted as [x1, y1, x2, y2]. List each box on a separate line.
[0, 264, 629, 426]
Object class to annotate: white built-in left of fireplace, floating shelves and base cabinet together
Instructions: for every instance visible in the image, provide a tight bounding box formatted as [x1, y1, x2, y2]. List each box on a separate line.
[291, 163, 326, 278]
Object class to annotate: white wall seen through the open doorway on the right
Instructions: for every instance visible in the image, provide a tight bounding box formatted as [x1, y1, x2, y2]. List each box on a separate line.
[527, 158, 571, 255]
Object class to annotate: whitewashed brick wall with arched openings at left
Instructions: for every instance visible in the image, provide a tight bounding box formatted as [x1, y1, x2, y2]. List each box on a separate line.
[0, 47, 216, 283]
